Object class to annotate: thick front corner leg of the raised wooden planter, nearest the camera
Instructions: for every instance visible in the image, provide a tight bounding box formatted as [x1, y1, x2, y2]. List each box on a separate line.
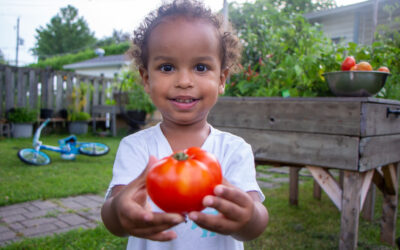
[339, 170, 362, 249]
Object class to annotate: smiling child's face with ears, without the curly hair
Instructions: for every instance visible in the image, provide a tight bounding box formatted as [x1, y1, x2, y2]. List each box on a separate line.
[140, 17, 228, 125]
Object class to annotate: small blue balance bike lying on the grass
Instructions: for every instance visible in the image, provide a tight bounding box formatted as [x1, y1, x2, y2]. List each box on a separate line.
[18, 119, 110, 166]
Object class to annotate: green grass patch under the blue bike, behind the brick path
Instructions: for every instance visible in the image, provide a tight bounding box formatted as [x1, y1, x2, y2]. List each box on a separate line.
[0, 135, 121, 206]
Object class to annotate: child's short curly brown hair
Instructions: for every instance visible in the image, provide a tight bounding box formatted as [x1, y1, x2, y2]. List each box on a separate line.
[127, 0, 241, 72]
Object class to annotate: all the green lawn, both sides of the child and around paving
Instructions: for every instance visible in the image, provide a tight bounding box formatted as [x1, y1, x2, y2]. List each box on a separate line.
[0, 136, 400, 250]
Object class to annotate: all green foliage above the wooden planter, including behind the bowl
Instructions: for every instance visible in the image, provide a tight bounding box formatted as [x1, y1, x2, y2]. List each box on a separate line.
[225, 0, 400, 99]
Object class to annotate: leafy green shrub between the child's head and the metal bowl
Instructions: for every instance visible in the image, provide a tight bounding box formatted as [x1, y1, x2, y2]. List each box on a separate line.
[226, 1, 335, 96]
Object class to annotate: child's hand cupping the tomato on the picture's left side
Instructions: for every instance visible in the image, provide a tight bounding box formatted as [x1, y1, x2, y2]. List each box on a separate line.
[102, 157, 184, 241]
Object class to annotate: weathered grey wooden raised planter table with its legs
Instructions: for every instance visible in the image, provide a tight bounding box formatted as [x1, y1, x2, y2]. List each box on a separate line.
[209, 97, 400, 249]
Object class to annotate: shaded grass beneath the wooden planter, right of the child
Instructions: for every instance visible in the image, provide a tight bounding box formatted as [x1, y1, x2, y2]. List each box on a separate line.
[245, 179, 400, 250]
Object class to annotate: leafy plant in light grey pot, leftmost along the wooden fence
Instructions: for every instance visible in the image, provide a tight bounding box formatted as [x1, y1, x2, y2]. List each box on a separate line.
[7, 107, 37, 138]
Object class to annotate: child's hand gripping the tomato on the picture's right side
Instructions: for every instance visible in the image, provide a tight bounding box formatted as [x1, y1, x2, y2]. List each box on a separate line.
[189, 179, 268, 240]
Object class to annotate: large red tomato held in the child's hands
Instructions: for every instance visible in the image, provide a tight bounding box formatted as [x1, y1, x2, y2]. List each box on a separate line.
[146, 147, 222, 213]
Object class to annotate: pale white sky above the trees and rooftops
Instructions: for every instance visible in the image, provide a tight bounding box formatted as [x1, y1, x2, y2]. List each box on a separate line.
[0, 0, 365, 66]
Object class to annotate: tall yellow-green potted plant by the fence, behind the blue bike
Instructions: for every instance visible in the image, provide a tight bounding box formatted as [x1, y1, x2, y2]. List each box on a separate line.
[68, 83, 91, 134]
